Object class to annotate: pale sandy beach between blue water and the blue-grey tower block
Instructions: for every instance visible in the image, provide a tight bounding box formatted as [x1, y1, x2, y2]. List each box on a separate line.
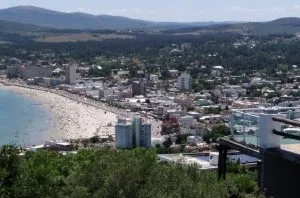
[0, 86, 117, 140]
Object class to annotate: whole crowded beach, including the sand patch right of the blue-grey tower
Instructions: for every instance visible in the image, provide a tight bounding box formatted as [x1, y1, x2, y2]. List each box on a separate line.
[0, 84, 161, 140]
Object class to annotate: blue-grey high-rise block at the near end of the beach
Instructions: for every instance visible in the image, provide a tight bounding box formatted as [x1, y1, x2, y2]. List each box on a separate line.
[116, 116, 151, 148]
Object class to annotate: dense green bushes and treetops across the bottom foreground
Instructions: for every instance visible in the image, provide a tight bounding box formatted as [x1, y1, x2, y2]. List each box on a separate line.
[0, 146, 258, 198]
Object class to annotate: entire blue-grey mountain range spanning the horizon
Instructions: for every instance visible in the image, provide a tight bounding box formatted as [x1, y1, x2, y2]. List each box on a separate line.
[0, 6, 300, 34]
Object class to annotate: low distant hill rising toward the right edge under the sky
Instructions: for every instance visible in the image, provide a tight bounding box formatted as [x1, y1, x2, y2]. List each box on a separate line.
[165, 17, 300, 34]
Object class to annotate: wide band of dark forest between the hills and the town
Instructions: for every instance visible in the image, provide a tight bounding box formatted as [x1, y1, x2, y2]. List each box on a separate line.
[0, 30, 300, 78]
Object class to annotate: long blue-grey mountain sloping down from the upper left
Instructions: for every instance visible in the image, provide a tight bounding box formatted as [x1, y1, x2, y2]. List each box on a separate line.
[0, 6, 239, 30]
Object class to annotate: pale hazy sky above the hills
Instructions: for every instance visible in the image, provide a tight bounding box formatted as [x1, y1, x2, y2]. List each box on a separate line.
[0, 0, 300, 21]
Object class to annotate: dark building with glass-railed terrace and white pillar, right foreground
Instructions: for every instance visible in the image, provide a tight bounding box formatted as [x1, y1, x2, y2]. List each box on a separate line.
[218, 111, 300, 198]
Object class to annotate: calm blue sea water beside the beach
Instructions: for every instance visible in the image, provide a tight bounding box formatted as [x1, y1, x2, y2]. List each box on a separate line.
[0, 87, 51, 146]
